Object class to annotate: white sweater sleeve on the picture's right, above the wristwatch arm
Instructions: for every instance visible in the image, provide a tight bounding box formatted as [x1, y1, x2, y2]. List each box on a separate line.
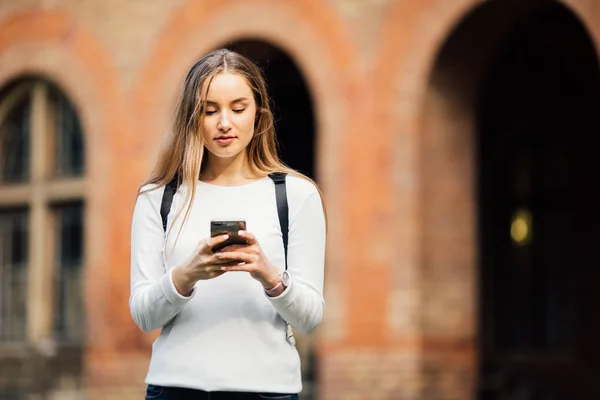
[267, 192, 326, 333]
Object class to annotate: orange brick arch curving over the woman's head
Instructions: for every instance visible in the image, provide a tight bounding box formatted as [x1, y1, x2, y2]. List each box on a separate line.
[133, 0, 367, 346]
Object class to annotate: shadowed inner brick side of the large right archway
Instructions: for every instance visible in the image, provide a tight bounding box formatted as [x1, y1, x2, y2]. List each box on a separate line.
[418, 2, 597, 346]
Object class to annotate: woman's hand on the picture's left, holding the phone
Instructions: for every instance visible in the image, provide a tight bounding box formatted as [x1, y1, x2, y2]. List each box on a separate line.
[171, 235, 234, 296]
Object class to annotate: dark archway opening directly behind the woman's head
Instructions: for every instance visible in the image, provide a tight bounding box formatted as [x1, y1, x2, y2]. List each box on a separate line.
[221, 39, 316, 179]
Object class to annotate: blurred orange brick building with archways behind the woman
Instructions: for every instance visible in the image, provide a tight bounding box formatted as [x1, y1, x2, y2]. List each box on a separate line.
[0, 0, 600, 400]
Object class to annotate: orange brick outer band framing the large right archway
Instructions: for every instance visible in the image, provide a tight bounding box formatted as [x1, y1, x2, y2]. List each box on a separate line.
[373, 0, 600, 344]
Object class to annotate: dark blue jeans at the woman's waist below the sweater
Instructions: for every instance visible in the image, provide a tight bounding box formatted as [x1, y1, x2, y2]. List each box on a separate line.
[146, 385, 298, 400]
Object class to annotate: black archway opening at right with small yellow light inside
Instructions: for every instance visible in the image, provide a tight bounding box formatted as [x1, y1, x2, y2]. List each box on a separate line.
[477, 3, 600, 400]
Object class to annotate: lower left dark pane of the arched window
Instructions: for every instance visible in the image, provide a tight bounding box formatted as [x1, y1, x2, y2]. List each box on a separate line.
[0, 210, 28, 342]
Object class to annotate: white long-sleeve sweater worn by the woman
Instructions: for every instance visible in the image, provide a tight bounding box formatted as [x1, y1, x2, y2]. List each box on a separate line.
[129, 176, 325, 393]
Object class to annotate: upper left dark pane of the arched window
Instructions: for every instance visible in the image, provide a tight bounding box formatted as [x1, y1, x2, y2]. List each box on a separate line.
[0, 95, 31, 183]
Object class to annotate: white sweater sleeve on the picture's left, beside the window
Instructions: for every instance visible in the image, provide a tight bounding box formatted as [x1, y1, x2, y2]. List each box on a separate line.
[129, 190, 195, 332]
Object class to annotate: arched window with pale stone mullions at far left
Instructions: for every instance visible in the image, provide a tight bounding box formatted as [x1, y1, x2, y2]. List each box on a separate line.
[0, 78, 85, 394]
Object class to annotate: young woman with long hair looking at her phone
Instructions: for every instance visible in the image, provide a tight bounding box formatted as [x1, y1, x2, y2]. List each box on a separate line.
[129, 50, 326, 400]
